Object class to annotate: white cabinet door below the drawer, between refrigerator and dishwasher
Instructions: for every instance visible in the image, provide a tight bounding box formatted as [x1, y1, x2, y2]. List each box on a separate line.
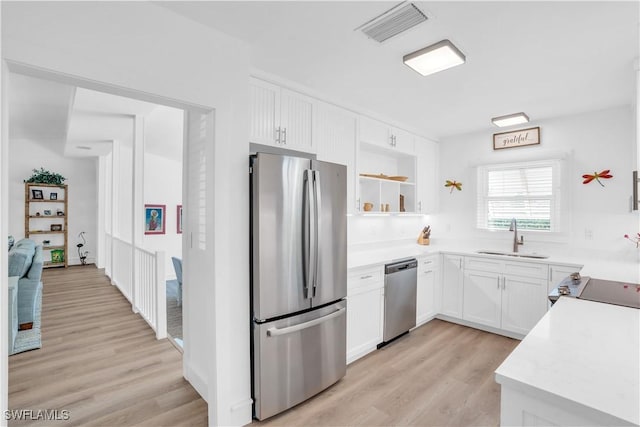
[347, 289, 384, 363]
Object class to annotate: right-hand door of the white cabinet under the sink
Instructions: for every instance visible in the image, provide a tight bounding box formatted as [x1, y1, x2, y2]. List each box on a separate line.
[502, 275, 547, 335]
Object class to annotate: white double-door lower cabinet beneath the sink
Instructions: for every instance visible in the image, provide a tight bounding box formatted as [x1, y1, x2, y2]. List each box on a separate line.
[462, 257, 548, 335]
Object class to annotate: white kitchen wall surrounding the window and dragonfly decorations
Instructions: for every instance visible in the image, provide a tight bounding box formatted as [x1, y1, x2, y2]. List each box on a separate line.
[433, 107, 640, 282]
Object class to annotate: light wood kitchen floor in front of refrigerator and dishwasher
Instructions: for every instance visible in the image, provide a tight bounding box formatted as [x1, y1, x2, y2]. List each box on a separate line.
[254, 320, 519, 426]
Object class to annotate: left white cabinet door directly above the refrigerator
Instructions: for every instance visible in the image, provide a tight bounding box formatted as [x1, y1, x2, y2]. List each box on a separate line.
[249, 79, 280, 146]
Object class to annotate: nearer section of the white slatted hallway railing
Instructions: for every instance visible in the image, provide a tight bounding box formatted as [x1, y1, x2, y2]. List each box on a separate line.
[134, 248, 167, 339]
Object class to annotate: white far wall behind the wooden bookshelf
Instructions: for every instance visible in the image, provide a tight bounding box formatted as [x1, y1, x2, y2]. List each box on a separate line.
[9, 139, 97, 264]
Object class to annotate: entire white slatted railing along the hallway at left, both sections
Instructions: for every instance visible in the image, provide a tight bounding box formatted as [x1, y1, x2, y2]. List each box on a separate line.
[105, 233, 167, 339]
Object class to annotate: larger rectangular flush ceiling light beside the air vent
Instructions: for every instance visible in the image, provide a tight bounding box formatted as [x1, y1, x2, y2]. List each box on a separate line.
[402, 40, 466, 76]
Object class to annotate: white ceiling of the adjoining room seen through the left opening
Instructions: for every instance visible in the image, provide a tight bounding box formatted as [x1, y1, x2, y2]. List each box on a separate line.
[9, 74, 183, 159]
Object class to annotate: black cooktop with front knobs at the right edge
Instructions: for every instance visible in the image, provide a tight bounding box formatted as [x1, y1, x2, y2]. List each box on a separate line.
[549, 277, 640, 308]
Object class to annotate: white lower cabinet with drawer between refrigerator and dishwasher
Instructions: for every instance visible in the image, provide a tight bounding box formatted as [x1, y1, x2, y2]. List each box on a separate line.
[347, 265, 384, 363]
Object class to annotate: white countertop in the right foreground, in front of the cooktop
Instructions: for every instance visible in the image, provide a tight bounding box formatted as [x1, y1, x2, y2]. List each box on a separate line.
[496, 298, 640, 424]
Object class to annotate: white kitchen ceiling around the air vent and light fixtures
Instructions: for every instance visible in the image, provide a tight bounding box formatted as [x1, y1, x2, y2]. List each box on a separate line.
[157, 1, 639, 137]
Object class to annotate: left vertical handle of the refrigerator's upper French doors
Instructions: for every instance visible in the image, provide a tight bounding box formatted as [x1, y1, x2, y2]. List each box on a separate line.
[302, 169, 317, 298]
